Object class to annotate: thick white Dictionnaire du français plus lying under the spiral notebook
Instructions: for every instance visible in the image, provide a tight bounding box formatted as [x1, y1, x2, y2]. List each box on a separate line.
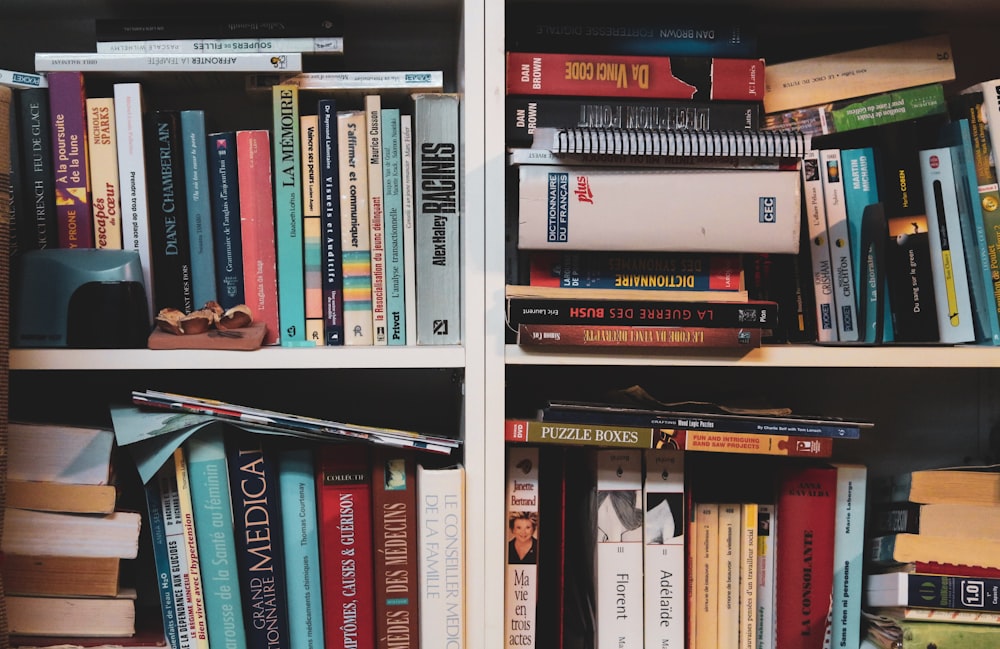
[518, 165, 801, 253]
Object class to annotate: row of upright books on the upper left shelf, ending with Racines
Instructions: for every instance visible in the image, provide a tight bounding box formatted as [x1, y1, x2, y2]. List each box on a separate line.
[5, 72, 461, 345]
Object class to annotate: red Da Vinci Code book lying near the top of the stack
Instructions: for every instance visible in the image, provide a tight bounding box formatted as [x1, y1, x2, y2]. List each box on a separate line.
[507, 52, 764, 101]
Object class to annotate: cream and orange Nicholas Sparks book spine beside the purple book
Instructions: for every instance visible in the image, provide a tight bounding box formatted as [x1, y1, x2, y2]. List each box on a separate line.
[86, 97, 122, 250]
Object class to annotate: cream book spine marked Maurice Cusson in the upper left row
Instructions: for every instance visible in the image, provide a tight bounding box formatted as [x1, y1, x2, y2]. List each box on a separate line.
[365, 95, 389, 345]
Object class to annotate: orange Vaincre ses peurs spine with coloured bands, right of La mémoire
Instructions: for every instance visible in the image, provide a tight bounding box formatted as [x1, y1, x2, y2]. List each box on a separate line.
[299, 115, 326, 345]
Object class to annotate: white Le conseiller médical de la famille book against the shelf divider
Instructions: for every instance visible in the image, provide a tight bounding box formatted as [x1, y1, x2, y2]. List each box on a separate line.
[417, 464, 466, 649]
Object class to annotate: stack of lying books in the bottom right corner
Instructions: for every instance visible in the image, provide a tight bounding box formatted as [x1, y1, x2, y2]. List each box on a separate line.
[864, 467, 1000, 647]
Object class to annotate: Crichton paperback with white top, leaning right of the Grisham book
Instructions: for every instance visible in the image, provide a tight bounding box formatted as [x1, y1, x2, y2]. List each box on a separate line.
[819, 149, 858, 342]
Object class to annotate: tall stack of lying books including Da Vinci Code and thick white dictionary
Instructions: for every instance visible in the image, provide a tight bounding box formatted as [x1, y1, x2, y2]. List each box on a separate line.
[506, 4, 806, 351]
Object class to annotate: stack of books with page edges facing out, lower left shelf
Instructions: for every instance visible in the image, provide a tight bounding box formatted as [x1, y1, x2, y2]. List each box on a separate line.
[0, 422, 141, 643]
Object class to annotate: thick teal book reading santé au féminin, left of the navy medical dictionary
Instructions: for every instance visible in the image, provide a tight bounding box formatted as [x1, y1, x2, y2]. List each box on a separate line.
[185, 426, 247, 649]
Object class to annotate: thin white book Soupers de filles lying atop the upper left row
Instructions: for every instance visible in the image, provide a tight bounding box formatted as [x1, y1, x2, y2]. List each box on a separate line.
[96, 36, 344, 54]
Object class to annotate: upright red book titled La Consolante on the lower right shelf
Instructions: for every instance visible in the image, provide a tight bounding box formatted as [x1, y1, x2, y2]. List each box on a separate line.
[775, 466, 837, 649]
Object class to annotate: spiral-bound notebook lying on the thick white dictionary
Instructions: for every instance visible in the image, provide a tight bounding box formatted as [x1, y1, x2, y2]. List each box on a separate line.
[533, 128, 810, 158]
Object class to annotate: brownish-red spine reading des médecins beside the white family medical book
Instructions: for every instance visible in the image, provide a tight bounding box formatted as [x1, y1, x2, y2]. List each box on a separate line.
[372, 447, 421, 649]
